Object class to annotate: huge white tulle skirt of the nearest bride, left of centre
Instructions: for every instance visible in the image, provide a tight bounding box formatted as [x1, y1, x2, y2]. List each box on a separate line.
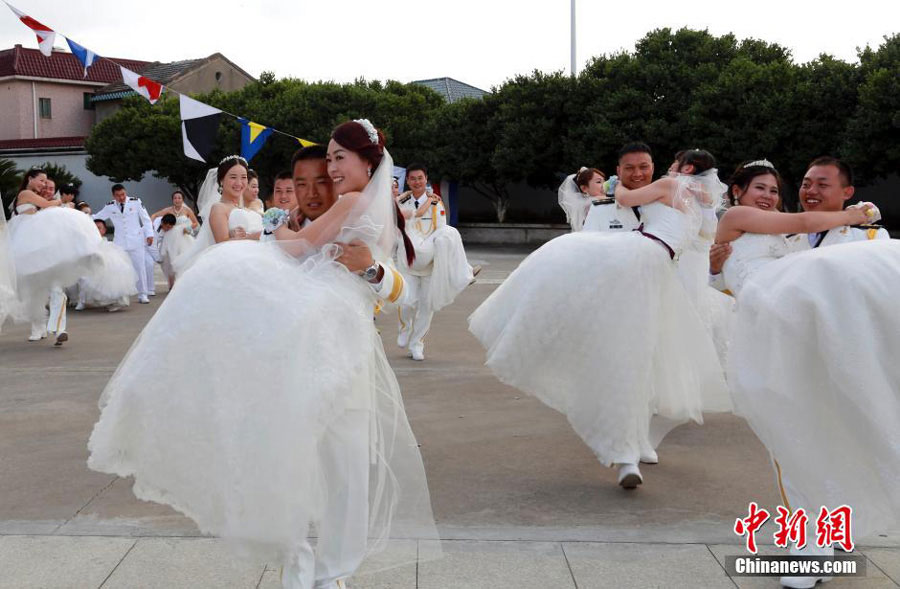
[88, 241, 437, 564]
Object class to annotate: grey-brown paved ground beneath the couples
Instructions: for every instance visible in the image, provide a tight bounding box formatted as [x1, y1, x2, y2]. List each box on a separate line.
[0, 248, 900, 589]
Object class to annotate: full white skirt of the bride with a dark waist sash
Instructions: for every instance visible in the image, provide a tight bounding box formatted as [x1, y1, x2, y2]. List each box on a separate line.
[469, 232, 729, 464]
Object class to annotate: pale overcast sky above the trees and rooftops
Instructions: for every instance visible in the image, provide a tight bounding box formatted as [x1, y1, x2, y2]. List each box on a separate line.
[0, 0, 900, 90]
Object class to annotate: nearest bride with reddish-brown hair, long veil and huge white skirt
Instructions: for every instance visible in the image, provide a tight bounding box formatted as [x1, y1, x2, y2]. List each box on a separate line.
[88, 120, 437, 588]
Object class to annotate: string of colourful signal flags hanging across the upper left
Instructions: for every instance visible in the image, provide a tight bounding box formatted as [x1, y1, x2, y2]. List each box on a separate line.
[4, 0, 316, 163]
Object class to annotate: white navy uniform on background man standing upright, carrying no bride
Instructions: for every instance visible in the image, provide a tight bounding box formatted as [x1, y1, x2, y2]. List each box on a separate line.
[93, 196, 154, 299]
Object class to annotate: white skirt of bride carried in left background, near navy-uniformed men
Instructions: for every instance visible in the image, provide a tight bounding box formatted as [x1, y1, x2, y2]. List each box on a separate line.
[9, 207, 102, 300]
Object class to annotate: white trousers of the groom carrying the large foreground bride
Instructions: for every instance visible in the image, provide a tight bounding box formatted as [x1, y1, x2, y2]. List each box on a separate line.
[281, 410, 370, 589]
